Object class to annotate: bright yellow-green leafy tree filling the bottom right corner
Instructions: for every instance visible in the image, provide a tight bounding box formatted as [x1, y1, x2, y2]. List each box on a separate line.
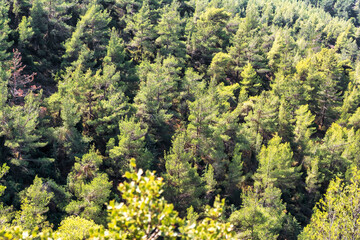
[300, 167, 360, 239]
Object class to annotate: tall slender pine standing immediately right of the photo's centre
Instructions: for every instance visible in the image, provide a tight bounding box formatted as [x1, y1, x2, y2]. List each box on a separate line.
[187, 83, 233, 166]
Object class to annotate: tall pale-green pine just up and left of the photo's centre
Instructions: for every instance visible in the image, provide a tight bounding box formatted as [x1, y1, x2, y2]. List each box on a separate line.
[134, 56, 180, 148]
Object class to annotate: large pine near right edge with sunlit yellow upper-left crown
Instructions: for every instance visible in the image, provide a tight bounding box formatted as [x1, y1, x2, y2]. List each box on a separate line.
[296, 49, 349, 127]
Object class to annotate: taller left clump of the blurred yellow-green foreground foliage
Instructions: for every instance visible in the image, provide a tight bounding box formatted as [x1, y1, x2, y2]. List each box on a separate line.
[91, 162, 181, 239]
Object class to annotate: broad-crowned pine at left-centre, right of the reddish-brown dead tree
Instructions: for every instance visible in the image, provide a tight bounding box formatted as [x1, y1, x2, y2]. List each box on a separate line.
[59, 65, 128, 145]
